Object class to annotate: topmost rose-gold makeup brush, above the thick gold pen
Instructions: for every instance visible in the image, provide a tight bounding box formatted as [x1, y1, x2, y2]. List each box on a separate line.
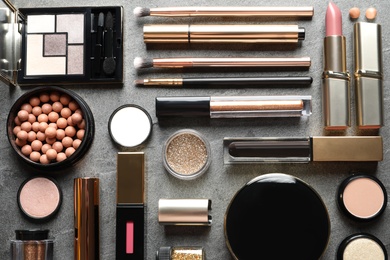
[133, 6, 314, 17]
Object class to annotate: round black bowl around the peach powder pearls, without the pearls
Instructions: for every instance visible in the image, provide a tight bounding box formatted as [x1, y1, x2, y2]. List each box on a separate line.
[7, 86, 95, 172]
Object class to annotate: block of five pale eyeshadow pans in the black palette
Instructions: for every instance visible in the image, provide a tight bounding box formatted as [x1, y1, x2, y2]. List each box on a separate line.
[26, 14, 85, 76]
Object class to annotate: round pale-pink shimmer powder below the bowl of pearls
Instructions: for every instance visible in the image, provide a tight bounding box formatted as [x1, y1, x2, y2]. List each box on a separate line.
[18, 177, 62, 220]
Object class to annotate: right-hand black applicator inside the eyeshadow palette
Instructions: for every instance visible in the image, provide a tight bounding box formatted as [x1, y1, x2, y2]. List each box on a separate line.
[103, 12, 116, 75]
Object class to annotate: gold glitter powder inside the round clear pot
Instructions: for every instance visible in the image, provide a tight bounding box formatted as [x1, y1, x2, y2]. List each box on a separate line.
[166, 133, 208, 175]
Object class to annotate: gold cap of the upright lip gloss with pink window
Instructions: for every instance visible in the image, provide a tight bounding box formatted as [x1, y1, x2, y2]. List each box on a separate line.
[116, 152, 145, 204]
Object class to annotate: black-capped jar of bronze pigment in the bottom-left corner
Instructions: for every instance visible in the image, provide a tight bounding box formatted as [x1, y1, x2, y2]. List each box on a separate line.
[11, 230, 54, 260]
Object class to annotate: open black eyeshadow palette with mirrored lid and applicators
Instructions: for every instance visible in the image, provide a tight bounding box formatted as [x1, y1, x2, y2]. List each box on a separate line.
[0, 1, 123, 85]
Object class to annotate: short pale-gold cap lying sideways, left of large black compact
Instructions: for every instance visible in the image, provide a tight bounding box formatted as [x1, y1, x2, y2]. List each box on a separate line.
[158, 199, 212, 226]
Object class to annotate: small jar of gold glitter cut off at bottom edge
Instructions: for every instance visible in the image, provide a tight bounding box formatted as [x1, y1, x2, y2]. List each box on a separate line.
[156, 246, 206, 260]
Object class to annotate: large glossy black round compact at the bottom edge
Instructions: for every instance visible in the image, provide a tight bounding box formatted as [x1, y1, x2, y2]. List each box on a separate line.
[224, 173, 330, 260]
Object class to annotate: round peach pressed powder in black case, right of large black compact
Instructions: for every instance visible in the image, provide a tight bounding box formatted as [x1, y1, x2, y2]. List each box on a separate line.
[337, 173, 387, 222]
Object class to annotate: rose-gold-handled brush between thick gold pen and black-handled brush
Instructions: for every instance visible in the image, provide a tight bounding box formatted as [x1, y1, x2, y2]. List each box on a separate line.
[134, 57, 311, 69]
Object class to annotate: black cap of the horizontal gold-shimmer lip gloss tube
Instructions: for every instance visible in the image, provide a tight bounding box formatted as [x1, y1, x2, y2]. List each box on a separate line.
[156, 97, 210, 117]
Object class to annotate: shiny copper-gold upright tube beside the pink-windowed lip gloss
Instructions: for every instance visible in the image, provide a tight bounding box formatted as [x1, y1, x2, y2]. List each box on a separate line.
[74, 178, 100, 260]
